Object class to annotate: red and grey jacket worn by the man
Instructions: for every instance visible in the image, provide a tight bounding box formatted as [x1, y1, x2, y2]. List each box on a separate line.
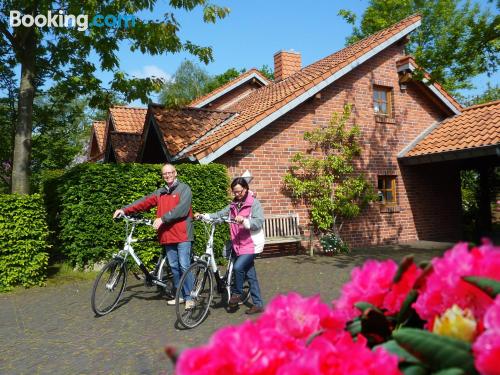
[123, 180, 194, 245]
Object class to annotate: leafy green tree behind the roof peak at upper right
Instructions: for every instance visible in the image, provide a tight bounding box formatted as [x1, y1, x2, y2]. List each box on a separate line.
[339, 0, 500, 95]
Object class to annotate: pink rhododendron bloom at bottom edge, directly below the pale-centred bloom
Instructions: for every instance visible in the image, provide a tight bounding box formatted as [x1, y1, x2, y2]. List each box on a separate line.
[277, 332, 401, 375]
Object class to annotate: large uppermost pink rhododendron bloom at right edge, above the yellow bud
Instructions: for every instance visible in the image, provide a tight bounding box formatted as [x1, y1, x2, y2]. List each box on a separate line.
[413, 243, 500, 329]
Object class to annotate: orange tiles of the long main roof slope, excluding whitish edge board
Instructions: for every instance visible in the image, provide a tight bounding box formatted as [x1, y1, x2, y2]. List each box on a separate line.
[190, 15, 421, 160]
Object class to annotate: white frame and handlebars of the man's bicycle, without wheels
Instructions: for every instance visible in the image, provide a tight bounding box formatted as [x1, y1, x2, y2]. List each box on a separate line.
[113, 215, 167, 288]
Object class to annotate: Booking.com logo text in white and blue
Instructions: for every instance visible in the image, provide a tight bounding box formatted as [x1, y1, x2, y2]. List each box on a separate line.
[9, 10, 135, 31]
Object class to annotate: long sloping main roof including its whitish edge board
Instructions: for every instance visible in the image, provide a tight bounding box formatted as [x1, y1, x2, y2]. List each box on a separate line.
[192, 15, 430, 164]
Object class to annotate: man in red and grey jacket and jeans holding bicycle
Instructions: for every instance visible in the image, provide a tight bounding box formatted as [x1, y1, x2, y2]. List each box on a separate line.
[113, 164, 194, 309]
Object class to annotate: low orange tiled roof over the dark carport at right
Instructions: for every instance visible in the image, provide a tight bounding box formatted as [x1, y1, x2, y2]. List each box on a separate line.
[402, 100, 500, 157]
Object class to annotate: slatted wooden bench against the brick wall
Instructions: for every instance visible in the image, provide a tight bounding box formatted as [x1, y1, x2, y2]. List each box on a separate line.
[264, 214, 303, 249]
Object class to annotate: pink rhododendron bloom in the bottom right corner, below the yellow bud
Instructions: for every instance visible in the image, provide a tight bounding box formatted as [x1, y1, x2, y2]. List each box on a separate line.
[472, 296, 500, 375]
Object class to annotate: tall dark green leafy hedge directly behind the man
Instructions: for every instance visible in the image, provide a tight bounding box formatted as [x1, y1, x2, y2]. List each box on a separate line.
[45, 163, 229, 267]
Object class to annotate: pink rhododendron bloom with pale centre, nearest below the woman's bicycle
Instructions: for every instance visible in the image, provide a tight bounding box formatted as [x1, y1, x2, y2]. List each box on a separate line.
[257, 293, 344, 344]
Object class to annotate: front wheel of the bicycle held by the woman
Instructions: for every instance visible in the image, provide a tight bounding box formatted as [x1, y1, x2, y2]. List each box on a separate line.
[175, 262, 213, 328]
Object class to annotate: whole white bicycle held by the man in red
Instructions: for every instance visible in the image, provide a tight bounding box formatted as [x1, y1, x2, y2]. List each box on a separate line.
[91, 215, 174, 316]
